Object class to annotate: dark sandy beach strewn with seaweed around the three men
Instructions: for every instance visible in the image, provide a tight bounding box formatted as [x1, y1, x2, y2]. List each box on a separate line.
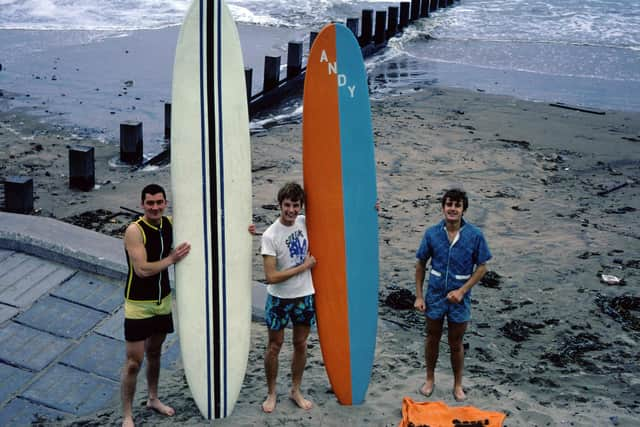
[0, 81, 640, 426]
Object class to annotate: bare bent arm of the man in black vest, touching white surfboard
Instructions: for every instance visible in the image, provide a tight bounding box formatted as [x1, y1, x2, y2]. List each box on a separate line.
[124, 224, 191, 277]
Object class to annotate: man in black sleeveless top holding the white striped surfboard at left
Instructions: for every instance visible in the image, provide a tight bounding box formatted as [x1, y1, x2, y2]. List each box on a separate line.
[122, 184, 191, 426]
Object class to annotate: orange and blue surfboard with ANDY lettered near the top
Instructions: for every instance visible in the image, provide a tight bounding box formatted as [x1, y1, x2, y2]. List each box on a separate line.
[302, 24, 378, 405]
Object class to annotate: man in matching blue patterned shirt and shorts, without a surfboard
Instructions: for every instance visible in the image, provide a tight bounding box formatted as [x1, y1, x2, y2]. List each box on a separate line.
[414, 189, 491, 402]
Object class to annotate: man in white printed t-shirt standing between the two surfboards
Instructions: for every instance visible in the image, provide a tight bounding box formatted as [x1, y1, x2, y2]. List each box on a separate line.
[249, 182, 316, 413]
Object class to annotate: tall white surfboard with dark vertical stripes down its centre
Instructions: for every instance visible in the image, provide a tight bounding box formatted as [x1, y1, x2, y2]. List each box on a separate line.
[171, 0, 252, 419]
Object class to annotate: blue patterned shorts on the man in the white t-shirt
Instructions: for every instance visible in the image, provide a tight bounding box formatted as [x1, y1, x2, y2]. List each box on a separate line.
[264, 294, 316, 331]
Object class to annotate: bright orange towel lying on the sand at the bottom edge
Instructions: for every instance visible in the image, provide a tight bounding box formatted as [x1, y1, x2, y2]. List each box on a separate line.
[398, 397, 507, 427]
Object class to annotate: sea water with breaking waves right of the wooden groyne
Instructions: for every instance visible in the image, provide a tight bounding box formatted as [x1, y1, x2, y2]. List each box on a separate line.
[372, 0, 640, 111]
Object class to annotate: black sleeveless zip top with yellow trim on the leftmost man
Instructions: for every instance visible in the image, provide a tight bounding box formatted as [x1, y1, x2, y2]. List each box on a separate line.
[124, 216, 173, 304]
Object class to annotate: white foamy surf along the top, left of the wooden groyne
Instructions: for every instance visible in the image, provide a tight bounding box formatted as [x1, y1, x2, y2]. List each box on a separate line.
[0, 0, 428, 30]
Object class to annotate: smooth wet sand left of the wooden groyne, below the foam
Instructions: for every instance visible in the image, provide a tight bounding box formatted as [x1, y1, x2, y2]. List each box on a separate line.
[0, 24, 308, 157]
